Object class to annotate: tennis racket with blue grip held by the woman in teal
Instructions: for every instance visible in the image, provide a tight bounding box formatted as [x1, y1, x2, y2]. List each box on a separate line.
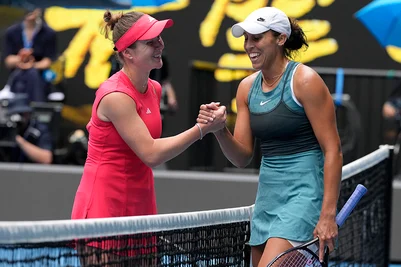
[267, 184, 367, 267]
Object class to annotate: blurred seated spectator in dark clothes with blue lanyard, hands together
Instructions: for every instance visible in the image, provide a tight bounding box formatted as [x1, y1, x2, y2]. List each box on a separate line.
[3, 9, 56, 102]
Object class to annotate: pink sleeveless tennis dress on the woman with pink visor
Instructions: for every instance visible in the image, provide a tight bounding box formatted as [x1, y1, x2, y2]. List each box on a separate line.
[71, 71, 161, 222]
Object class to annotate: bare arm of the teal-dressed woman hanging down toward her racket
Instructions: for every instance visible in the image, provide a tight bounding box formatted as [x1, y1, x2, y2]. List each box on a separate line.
[294, 65, 343, 257]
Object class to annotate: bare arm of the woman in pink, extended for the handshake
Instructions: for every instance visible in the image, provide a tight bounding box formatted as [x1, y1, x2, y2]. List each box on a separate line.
[97, 93, 225, 167]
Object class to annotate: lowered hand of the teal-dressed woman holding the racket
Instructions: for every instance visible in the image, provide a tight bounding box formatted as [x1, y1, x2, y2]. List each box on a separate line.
[313, 216, 338, 261]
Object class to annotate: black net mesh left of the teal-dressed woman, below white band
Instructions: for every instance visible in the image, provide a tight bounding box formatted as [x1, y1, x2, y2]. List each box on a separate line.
[0, 221, 250, 266]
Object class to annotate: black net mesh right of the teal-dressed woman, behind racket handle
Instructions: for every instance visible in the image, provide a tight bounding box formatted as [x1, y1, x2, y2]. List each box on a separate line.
[330, 158, 391, 266]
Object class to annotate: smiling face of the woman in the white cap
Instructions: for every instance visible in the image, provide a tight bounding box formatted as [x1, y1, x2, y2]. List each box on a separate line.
[244, 31, 284, 70]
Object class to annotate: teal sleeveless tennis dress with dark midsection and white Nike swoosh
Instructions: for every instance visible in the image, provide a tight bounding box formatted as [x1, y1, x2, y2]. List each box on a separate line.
[248, 61, 324, 246]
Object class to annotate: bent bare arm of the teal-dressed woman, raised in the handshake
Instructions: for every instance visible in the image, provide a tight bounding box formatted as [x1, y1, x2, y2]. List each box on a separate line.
[198, 76, 254, 168]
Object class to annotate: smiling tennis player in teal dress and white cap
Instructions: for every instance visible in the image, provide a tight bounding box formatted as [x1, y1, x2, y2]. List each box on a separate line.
[198, 7, 342, 267]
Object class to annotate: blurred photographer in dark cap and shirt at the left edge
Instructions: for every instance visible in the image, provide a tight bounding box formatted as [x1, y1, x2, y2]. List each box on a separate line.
[7, 95, 53, 164]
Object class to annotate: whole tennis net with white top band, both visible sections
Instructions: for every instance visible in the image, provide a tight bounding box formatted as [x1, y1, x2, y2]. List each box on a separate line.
[0, 146, 391, 266]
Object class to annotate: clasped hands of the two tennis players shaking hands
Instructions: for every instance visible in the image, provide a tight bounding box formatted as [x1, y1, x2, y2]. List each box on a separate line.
[196, 102, 227, 135]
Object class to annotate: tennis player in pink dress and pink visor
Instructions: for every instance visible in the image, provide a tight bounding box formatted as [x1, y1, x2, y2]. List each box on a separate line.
[71, 8, 226, 264]
